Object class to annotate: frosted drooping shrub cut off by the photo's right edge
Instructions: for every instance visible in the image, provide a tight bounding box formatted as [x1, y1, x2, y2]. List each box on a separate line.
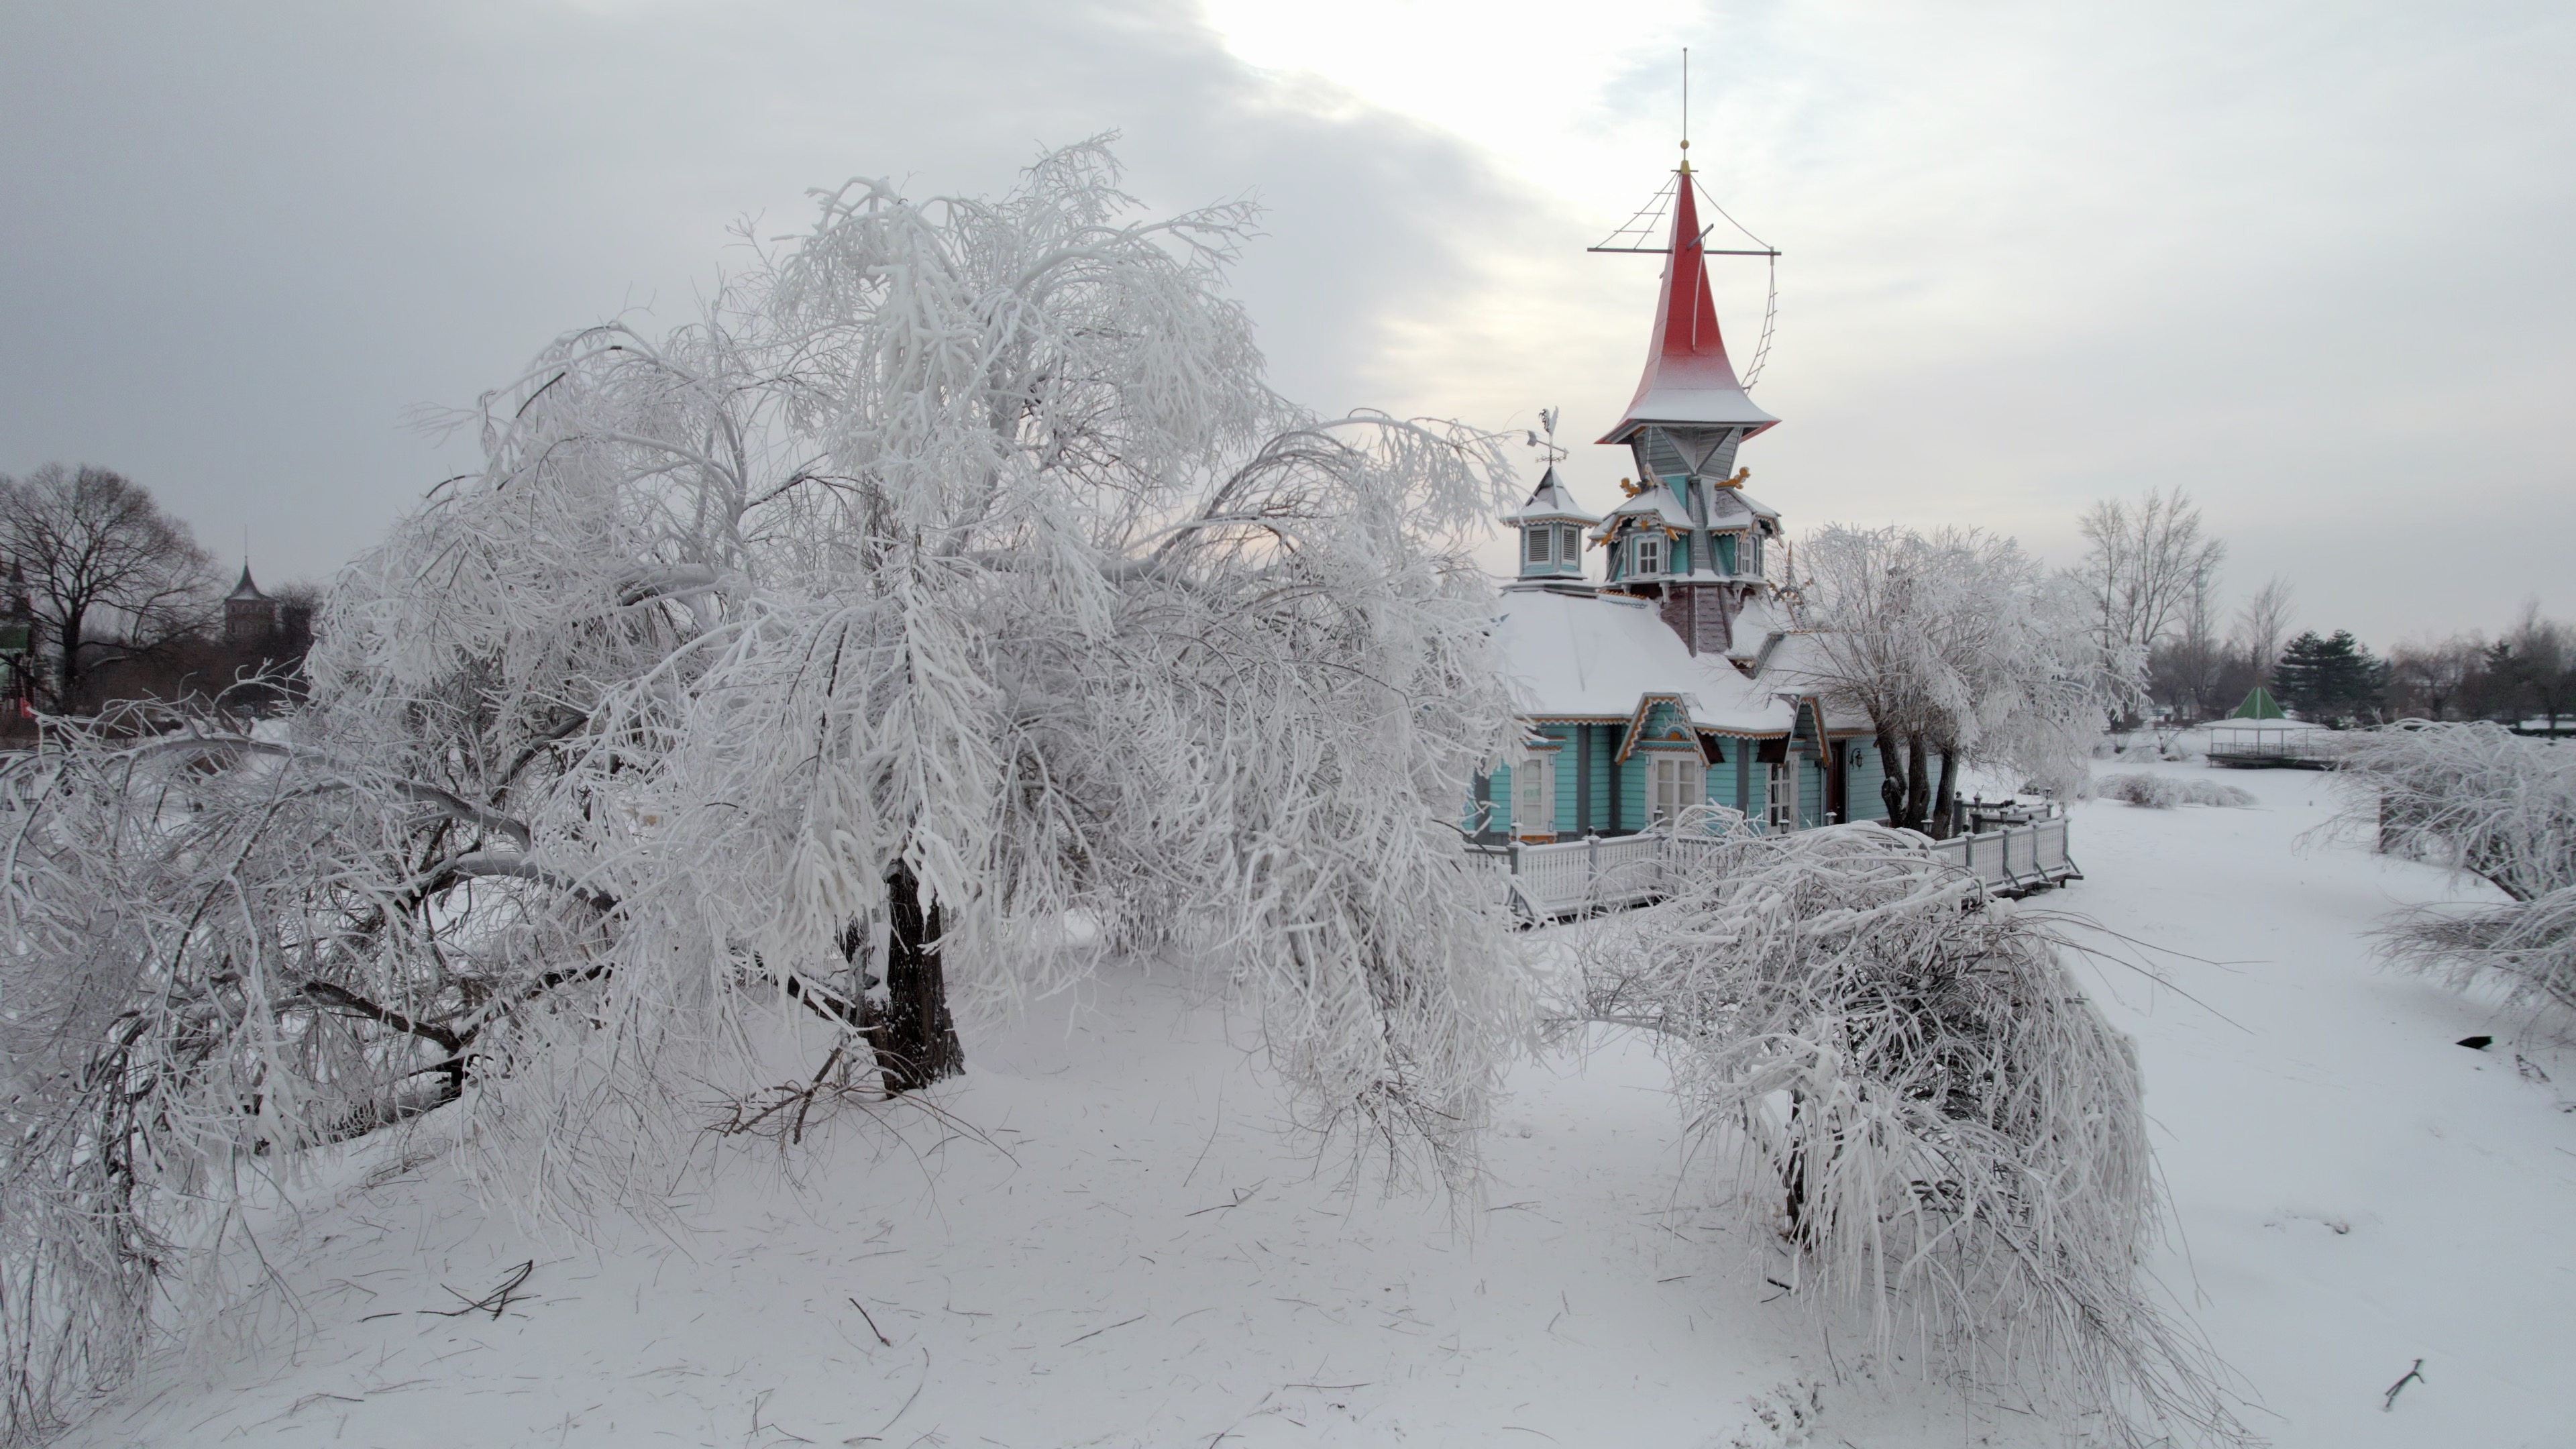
[2339, 722, 2576, 1008]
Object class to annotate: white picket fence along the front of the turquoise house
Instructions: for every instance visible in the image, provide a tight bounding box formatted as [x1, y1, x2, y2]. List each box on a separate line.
[1468, 815, 2084, 920]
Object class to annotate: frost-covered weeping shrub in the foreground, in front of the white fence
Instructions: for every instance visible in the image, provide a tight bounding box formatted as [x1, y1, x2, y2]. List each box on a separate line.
[1582, 825, 2241, 1444]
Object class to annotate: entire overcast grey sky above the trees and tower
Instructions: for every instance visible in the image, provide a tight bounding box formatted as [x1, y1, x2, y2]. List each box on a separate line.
[0, 0, 2576, 647]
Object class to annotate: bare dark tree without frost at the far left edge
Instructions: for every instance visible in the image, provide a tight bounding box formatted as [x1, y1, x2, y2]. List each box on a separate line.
[0, 464, 214, 709]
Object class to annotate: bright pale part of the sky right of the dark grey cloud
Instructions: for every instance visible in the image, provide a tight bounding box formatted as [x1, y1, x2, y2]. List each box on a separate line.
[1205, 0, 2576, 642]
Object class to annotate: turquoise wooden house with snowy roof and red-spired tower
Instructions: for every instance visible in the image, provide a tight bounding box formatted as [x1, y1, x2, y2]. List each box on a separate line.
[1468, 147, 1883, 843]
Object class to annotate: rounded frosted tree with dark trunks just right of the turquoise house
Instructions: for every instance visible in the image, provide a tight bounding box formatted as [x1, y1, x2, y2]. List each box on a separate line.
[1798, 526, 2143, 830]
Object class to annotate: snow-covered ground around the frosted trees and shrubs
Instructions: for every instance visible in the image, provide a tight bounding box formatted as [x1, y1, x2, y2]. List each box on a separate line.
[70, 765, 2576, 1449]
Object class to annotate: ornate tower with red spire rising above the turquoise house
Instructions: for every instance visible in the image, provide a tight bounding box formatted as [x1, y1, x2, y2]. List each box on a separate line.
[1597, 142, 1780, 652]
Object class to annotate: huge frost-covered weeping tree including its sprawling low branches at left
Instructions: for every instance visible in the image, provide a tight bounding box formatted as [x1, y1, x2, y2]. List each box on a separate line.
[0, 142, 1530, 1431]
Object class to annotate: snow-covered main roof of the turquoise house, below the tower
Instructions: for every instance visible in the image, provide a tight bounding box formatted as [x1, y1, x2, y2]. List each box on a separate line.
[1494, 590, 1795, 735]
